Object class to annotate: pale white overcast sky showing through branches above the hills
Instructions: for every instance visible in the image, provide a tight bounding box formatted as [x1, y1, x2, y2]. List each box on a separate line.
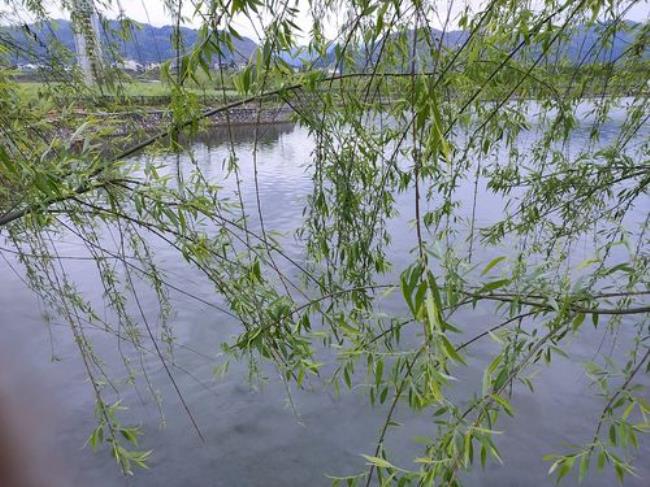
[0, 0, 650, 40]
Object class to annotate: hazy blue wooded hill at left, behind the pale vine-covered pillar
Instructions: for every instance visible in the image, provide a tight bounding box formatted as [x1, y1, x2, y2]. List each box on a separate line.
[0, 20, 257, 65]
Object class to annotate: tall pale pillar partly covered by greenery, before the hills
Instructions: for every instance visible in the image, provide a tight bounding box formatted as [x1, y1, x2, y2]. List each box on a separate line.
[71, 0, 102, 85]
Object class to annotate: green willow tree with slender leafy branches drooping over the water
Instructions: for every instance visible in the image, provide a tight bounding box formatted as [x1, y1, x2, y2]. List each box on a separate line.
[0, 0, 650, 485]
